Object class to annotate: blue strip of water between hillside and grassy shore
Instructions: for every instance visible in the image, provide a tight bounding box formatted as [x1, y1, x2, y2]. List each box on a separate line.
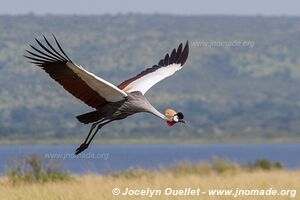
[0, 144, 300, 175]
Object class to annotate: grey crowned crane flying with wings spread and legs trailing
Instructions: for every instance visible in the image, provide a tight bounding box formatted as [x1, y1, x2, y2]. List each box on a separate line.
[24, 33, 189, 155]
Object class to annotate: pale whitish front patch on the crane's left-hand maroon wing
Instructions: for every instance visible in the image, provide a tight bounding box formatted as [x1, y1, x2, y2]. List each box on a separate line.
[66, 62, 127, 102]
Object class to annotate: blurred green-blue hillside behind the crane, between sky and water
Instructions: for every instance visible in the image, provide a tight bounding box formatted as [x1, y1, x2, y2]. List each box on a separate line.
[0, 15, 300, 142]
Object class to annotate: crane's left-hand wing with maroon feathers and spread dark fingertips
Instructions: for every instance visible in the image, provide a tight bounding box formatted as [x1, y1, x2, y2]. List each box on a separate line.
[24, 35, 127, 108]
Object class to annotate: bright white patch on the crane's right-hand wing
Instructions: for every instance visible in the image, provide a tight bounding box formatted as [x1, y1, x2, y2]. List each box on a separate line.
[123, 64, 182, 94]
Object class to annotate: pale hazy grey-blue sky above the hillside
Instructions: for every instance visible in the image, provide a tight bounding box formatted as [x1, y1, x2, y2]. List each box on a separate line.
[0, 0, 300, 16]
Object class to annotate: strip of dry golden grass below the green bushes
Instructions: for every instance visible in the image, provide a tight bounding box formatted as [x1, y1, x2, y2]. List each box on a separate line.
[0, 170, 300, 200]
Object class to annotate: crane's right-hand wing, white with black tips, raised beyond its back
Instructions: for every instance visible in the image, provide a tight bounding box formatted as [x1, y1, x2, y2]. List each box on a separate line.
[118, 41, 189, 94]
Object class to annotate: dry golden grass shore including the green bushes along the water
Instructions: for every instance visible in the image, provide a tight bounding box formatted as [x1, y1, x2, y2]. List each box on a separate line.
[0, 156, 300, 200]
